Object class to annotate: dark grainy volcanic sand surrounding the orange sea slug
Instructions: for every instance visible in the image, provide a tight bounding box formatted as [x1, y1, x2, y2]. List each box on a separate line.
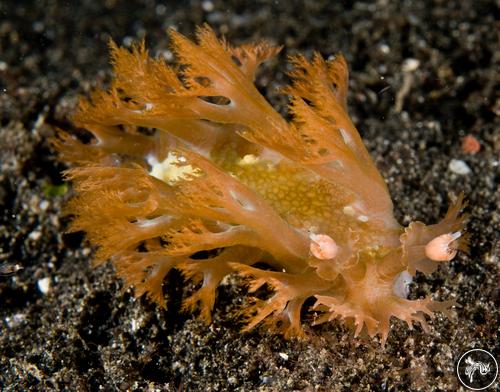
[0, 0, 500, 391]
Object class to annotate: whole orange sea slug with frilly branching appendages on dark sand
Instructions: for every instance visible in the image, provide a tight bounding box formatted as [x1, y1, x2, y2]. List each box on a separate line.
[55, 27, 467, 342]
